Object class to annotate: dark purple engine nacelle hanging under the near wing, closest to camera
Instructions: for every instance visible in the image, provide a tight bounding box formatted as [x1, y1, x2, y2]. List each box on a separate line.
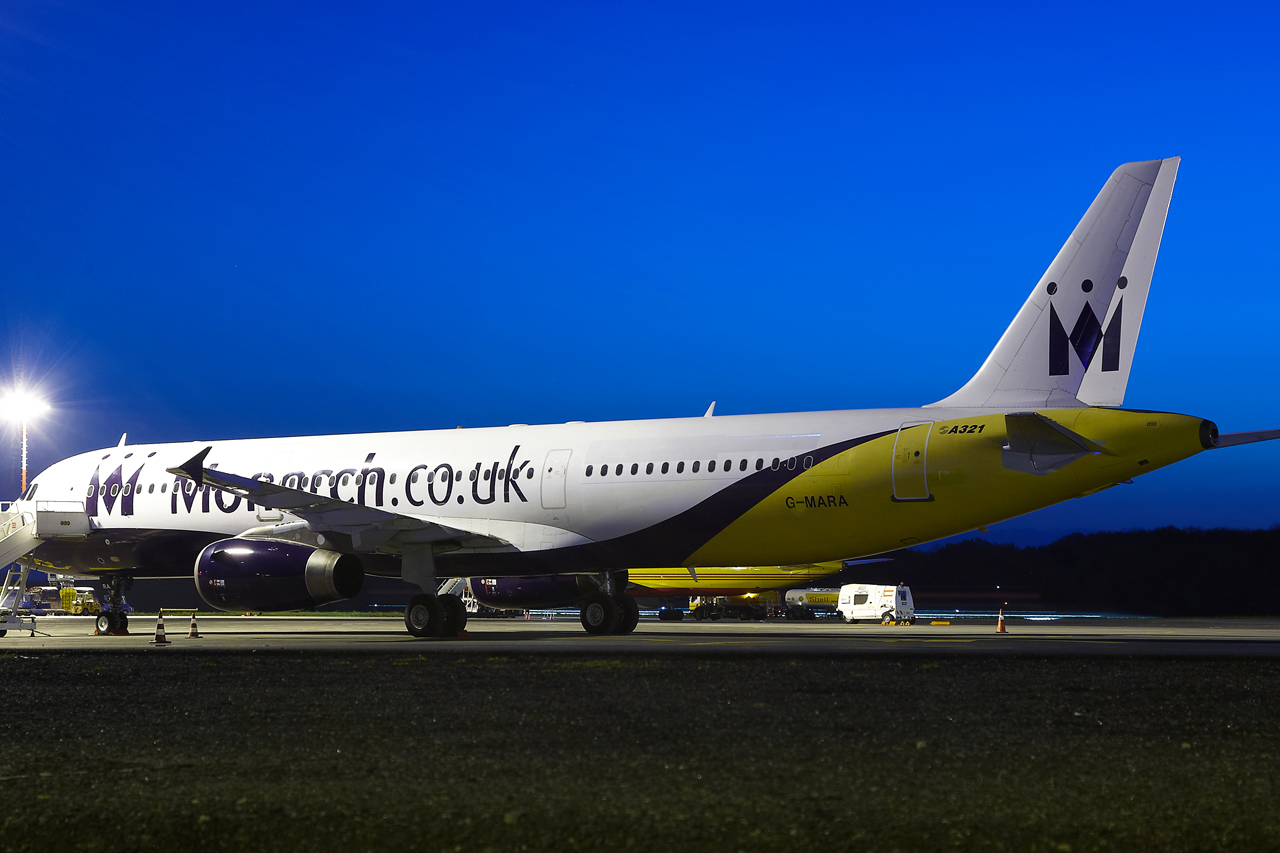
[196, 539, 365, 611]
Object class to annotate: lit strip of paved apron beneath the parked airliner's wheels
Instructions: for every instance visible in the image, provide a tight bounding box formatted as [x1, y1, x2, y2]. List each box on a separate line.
[0, 613, 1280, 657]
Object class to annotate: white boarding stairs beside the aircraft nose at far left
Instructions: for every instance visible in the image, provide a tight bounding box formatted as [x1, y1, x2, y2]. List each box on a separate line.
[0, 501, 90, 637]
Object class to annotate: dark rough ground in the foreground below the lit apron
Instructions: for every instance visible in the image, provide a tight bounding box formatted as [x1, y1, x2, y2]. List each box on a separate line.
[0, 649, 1280, 852]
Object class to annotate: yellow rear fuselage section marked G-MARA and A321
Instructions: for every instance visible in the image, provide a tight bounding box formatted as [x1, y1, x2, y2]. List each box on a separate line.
[687, 409, 1203, 566]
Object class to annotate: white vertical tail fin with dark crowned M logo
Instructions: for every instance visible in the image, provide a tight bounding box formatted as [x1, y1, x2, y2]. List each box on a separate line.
[932, 158, 1179, 409]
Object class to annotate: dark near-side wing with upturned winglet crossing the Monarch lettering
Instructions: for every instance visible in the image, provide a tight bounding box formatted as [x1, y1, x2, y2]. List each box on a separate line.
[168, 447, 494, 547]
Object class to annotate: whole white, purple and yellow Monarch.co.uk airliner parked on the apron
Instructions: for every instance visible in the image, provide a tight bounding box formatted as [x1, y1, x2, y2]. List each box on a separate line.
[0, 158, 1280, 637]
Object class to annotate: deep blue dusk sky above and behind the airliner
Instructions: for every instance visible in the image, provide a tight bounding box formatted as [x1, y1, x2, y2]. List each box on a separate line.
[0, 0, 1280, 542]
